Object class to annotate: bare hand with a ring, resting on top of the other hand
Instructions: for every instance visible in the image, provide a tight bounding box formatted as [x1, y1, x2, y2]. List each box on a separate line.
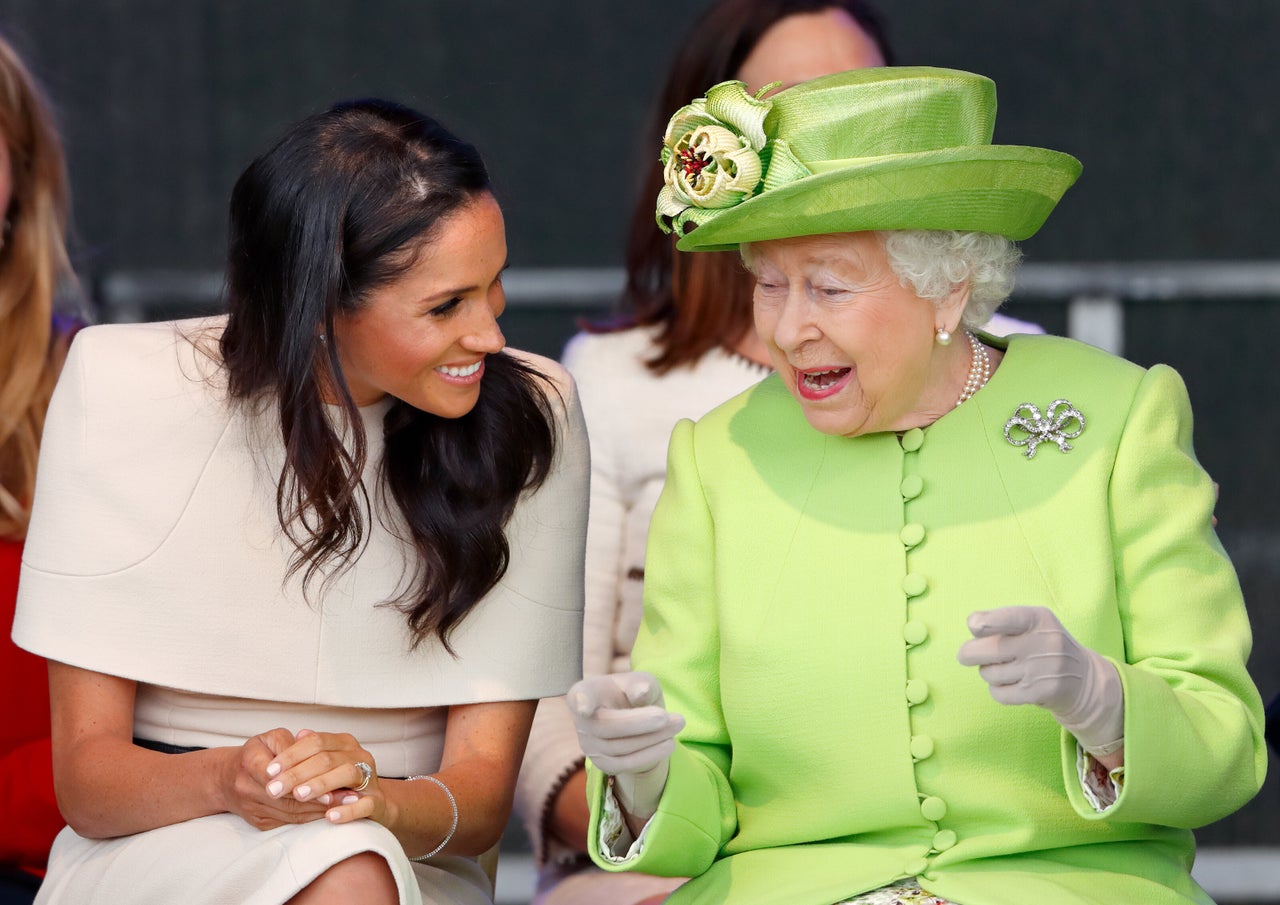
[258, 730, 387, 823]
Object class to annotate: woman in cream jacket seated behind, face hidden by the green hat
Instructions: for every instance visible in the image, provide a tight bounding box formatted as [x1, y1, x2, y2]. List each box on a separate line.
[506, 7, 893, 905]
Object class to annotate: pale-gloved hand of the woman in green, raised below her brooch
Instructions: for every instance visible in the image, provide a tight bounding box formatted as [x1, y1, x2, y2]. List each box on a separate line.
[957, 607, 1124, 757]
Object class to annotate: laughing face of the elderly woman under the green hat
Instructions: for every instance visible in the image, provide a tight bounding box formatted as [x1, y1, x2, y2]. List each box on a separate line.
[742, 232, 969, 436]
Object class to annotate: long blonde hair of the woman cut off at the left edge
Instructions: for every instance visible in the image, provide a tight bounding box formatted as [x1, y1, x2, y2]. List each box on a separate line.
[0, 37, 72, 540]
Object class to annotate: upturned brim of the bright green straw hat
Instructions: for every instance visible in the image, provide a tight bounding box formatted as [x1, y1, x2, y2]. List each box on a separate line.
[676, 145, 1080, 251]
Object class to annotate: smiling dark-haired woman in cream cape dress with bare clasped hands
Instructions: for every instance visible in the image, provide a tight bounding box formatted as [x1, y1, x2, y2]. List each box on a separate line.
[14, 101, 588, 905]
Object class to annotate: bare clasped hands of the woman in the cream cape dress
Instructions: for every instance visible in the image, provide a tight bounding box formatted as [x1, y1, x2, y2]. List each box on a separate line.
[223, 728, 387, 829]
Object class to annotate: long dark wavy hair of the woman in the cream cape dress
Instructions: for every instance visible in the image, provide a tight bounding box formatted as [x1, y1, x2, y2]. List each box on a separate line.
[220, 100, 556, 650]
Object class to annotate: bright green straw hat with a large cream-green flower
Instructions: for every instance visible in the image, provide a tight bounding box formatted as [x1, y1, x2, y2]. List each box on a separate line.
[658, 67, 1080, 251]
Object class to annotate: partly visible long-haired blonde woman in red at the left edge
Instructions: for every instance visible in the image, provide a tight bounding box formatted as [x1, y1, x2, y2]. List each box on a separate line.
[0, 30, 79, 905]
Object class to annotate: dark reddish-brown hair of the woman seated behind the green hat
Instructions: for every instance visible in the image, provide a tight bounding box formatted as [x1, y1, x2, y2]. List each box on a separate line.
[614, 0, 895, 374]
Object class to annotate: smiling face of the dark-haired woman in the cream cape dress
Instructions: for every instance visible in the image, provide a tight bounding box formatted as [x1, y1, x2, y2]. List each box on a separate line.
[333, 193, 507, 419]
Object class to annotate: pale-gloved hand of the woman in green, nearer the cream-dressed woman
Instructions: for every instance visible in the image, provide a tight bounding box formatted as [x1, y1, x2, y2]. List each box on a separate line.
[564, 672, 685, 823]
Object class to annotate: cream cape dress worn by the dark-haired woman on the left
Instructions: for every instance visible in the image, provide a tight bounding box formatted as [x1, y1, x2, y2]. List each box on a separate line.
[14, 319, 589, 905]
